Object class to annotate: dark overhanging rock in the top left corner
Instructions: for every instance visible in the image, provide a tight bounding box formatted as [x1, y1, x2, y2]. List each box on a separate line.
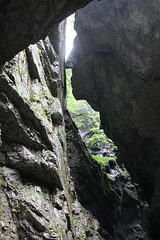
[0, 0, 91, 65]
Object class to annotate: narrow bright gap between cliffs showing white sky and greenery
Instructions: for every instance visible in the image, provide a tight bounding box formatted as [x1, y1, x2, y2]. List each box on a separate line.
[66, 14, 126, 178]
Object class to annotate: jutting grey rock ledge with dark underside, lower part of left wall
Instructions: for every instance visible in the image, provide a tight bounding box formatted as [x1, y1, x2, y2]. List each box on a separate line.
[1, 145, 62, 188]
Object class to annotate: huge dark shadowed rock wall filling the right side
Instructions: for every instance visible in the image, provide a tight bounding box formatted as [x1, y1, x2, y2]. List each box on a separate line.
[68, 0, 160, 239]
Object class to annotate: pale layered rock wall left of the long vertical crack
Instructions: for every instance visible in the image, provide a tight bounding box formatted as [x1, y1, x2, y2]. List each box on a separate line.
[0, 23, 74, 239]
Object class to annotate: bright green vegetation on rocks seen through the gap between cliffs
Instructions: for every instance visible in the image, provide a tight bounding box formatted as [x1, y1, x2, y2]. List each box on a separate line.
[66, 69, 117, 169]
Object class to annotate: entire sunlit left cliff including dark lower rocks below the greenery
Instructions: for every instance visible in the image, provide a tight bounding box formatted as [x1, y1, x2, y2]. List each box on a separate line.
[0, 11, 149, 240]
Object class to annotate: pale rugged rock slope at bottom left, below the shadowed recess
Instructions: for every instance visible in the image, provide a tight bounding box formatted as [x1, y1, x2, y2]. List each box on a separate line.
[0, 167, 68, 240]
